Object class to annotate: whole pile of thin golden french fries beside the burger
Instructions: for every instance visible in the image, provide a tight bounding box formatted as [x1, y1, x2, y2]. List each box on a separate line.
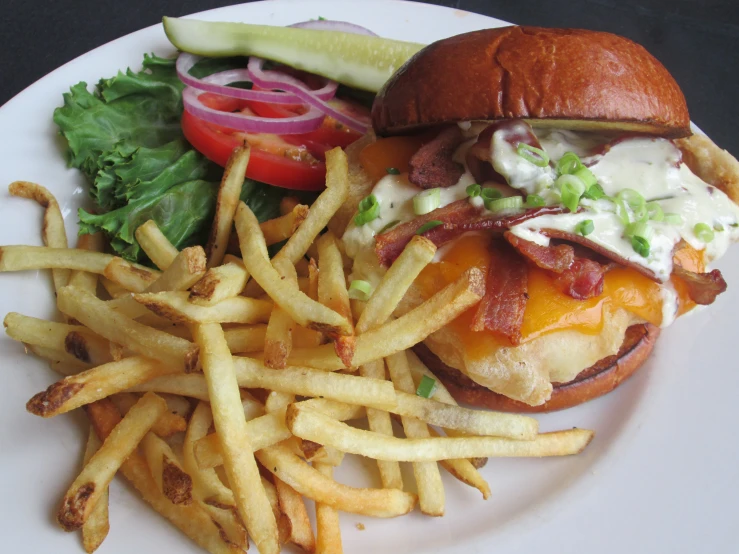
[0, 147, 593, 554]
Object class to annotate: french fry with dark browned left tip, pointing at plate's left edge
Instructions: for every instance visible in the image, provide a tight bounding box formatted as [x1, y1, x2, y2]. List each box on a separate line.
[26, 356, 178, 417]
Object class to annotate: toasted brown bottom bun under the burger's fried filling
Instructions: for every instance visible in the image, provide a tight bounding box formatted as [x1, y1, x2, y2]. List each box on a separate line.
[413, 323, 659, 413]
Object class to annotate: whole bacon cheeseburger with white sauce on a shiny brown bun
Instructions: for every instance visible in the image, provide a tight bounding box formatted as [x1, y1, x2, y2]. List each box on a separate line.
[331, 27, 739, 411]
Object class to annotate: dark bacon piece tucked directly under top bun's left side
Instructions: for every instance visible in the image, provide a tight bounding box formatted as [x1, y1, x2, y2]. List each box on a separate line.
[408, 125, 464, 189]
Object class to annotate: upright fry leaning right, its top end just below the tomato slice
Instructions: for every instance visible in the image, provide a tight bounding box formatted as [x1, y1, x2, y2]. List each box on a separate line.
[274, 147, 349, 266]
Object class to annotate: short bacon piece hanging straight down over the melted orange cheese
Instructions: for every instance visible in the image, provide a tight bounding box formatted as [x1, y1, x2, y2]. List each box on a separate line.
[472, 240, 528, 345]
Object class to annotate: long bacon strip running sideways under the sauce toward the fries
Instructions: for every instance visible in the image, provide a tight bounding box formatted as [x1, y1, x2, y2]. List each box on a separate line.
[375, 204, 565, 267]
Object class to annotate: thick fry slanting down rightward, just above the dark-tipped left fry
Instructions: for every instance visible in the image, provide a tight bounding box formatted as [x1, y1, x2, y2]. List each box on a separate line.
[57, 287, 198, 371]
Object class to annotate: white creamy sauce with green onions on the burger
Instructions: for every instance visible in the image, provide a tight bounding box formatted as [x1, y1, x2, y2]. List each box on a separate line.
[343, 122, 739, 326]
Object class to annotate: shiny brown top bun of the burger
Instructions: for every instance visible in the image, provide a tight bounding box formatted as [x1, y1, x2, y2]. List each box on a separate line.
[372, 27, 691, 138]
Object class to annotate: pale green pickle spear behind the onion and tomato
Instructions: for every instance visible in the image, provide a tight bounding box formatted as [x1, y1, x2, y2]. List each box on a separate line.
[162, 17, 424, 92]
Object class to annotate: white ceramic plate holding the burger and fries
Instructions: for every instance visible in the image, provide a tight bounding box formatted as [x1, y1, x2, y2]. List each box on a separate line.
[0, 0, 739, 554]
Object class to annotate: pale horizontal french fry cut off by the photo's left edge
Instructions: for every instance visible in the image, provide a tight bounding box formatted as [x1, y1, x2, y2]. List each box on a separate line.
[0, 246, 114, 275]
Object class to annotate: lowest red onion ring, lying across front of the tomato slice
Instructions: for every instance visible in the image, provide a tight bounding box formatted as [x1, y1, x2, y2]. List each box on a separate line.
[182, 87, 324, 135]
